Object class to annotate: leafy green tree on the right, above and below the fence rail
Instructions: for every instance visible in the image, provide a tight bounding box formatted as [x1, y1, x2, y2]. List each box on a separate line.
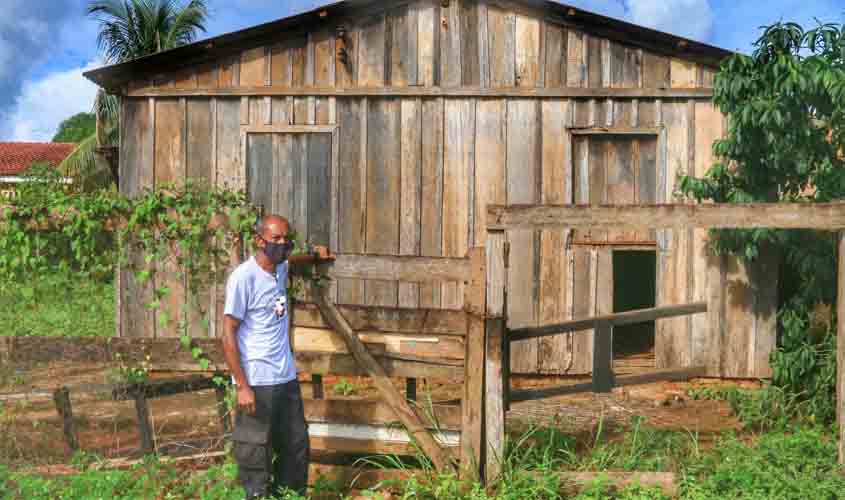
[681, 23, 845, 420]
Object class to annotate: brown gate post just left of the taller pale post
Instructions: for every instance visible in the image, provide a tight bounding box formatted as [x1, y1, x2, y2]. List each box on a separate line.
[461, 247, 487, 479]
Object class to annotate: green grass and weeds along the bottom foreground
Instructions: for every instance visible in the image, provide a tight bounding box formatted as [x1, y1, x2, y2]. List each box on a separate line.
[0, 422, 845, 500]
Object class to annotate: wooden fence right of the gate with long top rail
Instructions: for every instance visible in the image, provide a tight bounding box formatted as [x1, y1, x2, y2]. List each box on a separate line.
[485, 203, 845, 478]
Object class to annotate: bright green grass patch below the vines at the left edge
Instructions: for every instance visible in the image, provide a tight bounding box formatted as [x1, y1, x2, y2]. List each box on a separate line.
[0, 273, 115, 337]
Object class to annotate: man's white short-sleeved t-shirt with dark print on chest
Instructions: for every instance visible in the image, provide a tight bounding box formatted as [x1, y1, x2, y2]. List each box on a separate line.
[224, 257, 296, 386]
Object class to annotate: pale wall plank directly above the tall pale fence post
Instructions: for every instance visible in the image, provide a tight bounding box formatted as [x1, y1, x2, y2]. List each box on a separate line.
[474, 99, 507, 250]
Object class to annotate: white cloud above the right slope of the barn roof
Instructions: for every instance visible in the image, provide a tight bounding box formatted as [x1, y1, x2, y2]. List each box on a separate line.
[627, 0, 713, 41]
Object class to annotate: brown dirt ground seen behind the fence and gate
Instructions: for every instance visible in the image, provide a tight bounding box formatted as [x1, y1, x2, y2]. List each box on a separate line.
[0, 360, 750, 469]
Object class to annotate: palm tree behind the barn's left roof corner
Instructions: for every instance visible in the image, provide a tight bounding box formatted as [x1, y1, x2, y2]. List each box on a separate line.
[60, 0, 208, 189]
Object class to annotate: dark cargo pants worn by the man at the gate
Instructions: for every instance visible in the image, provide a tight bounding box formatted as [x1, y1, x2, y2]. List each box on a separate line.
[232, 380, 310, 499]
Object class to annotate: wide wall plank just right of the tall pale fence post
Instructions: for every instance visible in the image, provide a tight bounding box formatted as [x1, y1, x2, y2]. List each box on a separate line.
[507, 100, 540, 373]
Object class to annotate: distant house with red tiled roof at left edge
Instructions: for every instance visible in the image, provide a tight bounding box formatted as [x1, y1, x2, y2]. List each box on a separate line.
[0, 142, 76, 198]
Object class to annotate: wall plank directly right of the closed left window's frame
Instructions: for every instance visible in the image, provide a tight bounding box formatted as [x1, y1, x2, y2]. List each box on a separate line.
[337, 98, 367, 304]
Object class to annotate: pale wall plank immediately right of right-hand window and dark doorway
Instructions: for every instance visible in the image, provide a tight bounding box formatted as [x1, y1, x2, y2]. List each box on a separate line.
[655, 102, 691, 368]
